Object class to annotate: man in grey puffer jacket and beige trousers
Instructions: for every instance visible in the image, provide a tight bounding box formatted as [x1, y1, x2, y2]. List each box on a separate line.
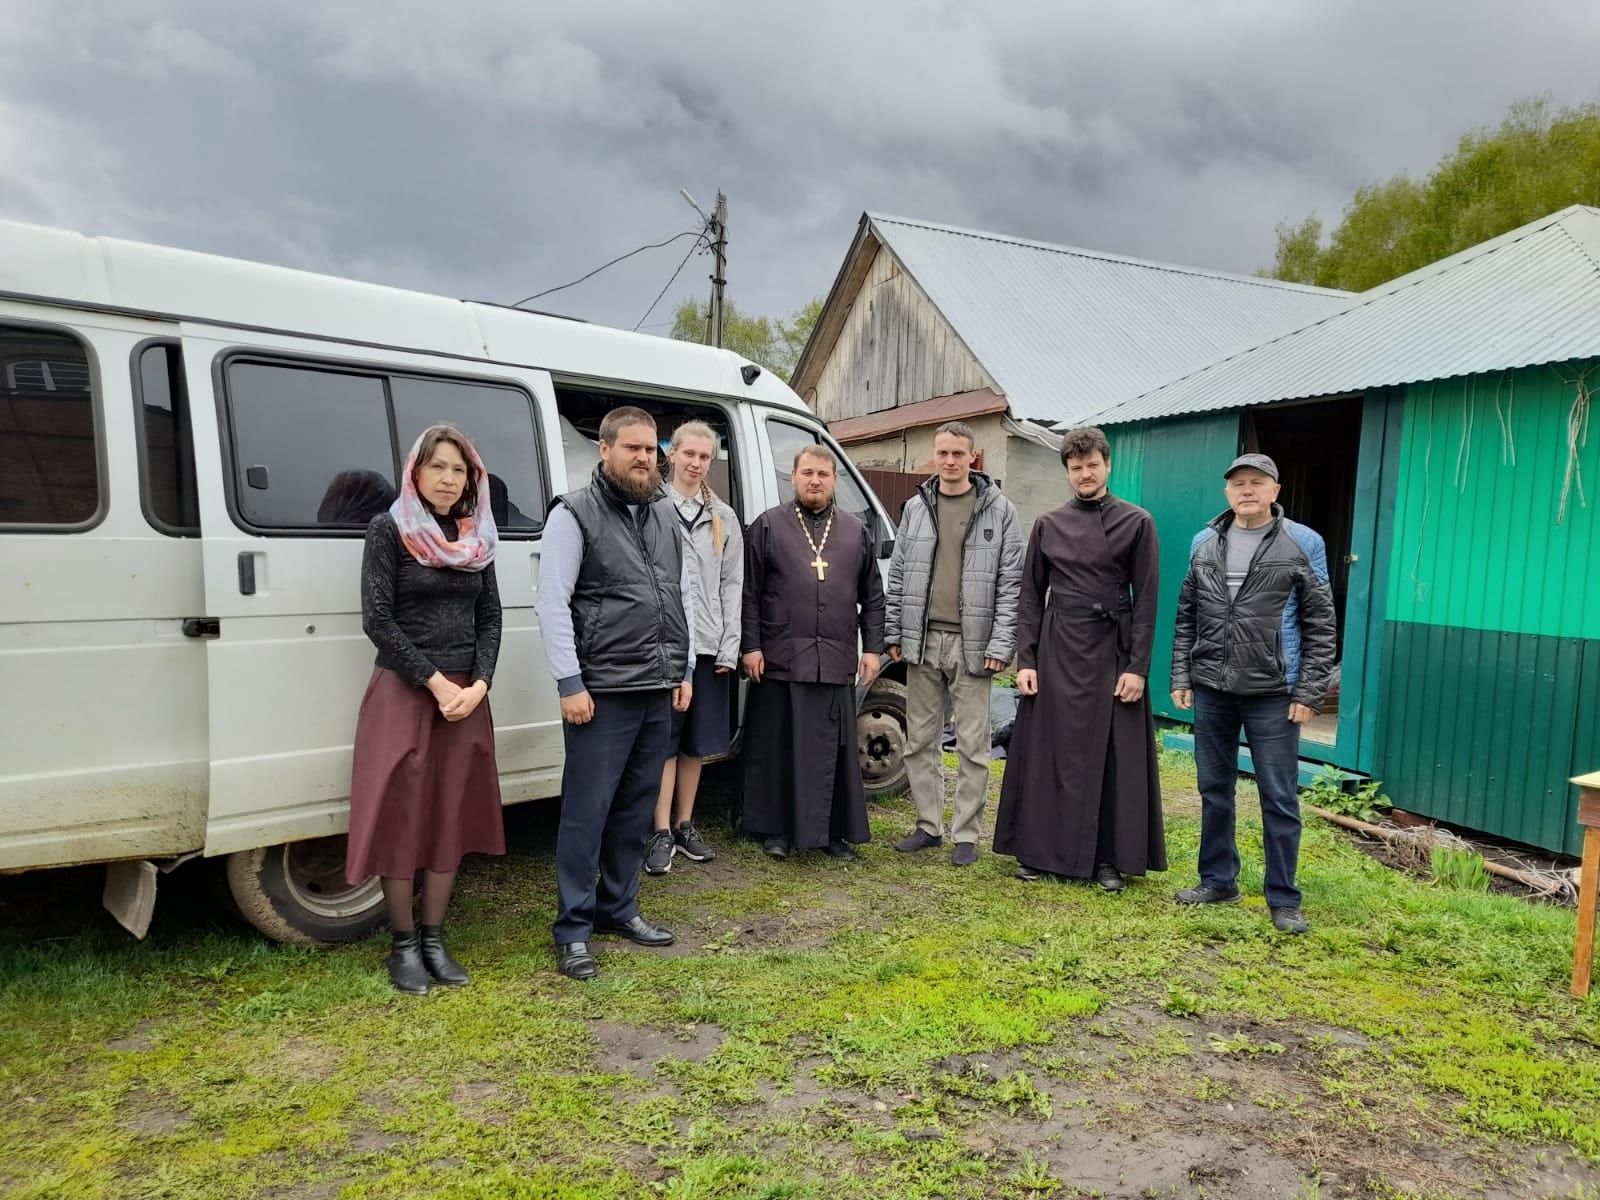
[885, 421, 1022, 867]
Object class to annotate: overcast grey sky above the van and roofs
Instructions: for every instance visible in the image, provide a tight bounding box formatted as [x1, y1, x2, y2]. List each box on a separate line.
[0, 0, 1600, 331]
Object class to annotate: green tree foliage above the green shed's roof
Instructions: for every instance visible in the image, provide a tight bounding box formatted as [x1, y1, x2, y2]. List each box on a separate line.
[1266, 99, 1600, 291]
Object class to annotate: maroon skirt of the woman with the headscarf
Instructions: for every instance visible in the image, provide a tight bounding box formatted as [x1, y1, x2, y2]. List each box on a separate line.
[344, 667, 506, 885]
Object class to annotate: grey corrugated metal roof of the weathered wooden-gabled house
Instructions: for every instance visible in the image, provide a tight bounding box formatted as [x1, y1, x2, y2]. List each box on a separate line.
[867, 213, 1350, 424]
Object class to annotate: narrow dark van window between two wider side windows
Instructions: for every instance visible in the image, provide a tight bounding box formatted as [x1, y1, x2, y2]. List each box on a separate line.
[133, 342, 200, 538]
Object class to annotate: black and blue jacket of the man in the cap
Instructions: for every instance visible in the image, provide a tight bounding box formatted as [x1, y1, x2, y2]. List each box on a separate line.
[1173, 504, 1338, 709]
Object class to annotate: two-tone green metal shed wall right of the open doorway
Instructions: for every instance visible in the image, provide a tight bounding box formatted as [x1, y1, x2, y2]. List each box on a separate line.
[1374, 365, 1600, 853]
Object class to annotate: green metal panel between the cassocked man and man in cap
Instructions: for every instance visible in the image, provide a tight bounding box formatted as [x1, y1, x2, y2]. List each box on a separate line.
[1106, 411, 1238, 722]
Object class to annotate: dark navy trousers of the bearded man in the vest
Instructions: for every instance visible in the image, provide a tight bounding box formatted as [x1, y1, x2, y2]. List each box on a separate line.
[554, 691, 672, 944]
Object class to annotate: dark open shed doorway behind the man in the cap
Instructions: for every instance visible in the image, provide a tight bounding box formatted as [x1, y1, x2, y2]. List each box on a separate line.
[1242, 397, 1363, 746]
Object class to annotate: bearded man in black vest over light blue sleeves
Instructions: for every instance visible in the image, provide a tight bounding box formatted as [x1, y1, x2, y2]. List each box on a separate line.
[534, 406, 694, 979]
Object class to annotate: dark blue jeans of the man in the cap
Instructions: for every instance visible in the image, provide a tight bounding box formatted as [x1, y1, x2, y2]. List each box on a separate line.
[1194, 688, 1301, 909]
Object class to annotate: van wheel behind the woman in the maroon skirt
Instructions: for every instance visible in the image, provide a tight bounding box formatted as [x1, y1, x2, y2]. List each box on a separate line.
[227, 835, 386, 946]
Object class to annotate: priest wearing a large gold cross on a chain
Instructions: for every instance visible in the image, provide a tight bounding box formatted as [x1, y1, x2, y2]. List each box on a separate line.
[741, 446, 883, 859]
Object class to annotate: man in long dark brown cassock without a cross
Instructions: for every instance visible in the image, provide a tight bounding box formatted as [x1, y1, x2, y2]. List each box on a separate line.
[995, 429, 1166, 891]
